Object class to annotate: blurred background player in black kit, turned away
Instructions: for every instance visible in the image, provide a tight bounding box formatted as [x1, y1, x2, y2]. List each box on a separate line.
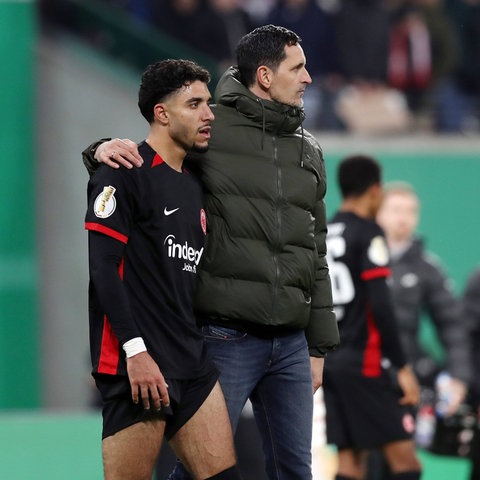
[324, 155, 421, 480]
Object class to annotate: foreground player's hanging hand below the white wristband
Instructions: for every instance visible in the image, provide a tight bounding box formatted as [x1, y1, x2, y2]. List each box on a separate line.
[127, 352, 170, 410]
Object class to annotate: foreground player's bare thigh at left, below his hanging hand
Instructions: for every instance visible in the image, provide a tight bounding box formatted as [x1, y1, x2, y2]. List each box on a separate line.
[102, 419, 165, 480]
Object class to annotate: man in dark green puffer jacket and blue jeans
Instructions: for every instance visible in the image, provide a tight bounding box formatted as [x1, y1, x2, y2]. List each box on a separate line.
[84, 25, 339, 480]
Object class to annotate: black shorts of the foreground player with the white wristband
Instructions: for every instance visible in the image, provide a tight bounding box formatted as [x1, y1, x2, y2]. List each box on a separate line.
[95, 369, 219, 440]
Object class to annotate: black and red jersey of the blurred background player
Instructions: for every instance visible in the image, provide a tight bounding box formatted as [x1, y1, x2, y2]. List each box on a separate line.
[327, 212, 405, 377]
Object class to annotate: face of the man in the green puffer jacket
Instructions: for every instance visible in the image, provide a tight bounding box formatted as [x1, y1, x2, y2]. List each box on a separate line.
[269, 45, 312, 107]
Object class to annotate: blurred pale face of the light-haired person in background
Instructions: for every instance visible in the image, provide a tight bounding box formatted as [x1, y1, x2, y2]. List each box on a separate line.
[377, 192, 419, 241]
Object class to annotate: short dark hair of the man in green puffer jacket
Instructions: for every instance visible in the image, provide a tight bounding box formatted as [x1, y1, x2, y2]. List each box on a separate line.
[236, 25, 301, 88]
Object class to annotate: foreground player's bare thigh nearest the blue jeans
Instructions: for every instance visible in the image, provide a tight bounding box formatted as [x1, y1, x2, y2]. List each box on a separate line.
[170, 382, 235, 478]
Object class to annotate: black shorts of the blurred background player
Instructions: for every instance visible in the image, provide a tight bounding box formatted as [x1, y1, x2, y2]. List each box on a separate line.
[323, 370, 415, 449]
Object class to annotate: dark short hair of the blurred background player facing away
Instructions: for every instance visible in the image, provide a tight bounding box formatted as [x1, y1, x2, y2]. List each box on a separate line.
[337, 155, 382, 198]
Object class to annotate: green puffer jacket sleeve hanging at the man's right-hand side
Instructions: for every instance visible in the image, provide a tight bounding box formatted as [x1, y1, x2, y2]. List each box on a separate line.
[306, 156, 340, 357]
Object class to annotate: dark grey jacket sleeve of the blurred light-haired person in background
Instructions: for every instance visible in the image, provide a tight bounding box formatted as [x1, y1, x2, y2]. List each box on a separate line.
[424, 255, 473, 382]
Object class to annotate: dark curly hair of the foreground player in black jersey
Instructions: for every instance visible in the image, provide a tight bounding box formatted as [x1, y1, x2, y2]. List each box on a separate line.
[138, 59, 210, 123]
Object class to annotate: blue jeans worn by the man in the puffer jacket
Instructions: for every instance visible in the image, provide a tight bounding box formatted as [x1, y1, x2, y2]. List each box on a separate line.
[169, 325, 313, 480]
